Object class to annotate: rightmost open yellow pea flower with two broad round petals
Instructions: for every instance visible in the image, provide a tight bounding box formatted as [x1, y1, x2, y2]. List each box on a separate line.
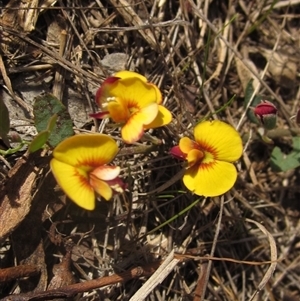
[170, 120, 243, 197]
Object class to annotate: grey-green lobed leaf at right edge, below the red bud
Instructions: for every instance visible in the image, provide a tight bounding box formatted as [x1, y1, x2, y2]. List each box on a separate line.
[271, 137, 300, 171]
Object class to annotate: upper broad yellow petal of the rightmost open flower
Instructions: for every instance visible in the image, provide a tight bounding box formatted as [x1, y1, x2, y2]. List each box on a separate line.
[194, 120, 243, 162]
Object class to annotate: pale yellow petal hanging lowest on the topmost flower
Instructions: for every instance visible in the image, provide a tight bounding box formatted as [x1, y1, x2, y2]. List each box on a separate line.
[121, 103, 158, 144]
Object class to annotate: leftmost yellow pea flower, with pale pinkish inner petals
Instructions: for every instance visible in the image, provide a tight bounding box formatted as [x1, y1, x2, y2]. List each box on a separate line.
[50, 134, 125, 210]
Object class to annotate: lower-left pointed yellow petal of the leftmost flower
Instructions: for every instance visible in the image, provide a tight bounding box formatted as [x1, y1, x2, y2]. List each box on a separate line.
[50, 159, 95, 210]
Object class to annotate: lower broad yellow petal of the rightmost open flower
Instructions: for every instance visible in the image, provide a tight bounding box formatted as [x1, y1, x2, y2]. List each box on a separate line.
[183, 161, 237, 197]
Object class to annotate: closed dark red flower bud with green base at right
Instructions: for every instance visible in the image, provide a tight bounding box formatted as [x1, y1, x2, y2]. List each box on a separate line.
[254, 100, 277, 130]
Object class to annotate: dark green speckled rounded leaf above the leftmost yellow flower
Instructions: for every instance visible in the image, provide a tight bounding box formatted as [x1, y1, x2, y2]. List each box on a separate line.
[33, 94, 74, 147]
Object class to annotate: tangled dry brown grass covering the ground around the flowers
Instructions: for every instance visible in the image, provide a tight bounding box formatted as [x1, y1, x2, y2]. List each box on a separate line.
[0, 0, 300, 301]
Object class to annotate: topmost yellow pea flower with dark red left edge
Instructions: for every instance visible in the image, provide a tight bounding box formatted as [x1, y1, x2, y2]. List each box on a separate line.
[90, 71, 172, 143]
